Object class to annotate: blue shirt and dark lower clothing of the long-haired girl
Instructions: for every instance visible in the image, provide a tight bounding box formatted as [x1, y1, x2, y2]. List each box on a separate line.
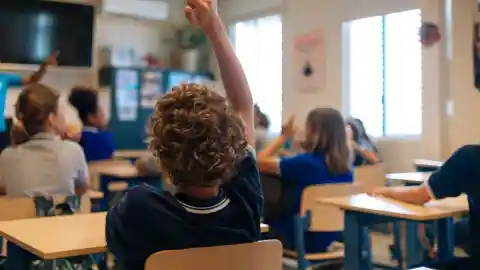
[272, 153, 353, 253]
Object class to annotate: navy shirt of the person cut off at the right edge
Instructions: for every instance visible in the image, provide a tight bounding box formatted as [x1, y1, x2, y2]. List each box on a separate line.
[426, 145, 480, 265]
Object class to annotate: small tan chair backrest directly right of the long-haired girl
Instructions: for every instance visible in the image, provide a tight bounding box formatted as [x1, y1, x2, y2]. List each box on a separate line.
[353, 163, 387, 192]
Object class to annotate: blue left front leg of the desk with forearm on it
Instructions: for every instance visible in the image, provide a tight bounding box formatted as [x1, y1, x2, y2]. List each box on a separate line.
[344, 211, 373, 270]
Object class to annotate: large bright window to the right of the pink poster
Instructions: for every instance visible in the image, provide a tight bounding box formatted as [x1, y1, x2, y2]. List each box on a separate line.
[348, 10, 422, 137]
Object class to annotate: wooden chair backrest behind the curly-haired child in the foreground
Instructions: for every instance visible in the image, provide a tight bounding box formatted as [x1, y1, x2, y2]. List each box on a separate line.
[145, 240, 283, 270]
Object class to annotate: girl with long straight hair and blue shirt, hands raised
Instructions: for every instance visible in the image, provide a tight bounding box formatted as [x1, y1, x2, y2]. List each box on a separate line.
[257, 108, 353, 253]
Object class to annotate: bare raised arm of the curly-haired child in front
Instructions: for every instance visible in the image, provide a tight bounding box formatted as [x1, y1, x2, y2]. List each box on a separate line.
[185, 0, 255, 145]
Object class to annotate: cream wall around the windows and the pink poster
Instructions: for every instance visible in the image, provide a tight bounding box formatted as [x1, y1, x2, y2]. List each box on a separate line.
[219, 0, 480, 171]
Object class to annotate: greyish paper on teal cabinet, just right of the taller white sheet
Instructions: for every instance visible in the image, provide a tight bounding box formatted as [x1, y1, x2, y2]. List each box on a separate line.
[140, 71, 163, 109]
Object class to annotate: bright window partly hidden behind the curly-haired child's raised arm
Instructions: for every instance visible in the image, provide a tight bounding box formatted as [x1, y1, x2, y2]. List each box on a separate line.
[232, 15, 282, 132]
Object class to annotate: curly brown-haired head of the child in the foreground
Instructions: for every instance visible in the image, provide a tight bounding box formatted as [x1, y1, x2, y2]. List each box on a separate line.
[150, 84, 247, 188]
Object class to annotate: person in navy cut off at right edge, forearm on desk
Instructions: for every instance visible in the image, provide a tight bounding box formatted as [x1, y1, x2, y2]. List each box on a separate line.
[373, 145, 480, 270]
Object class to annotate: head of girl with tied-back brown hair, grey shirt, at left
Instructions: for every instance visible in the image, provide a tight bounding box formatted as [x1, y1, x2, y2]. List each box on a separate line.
[12, 84, 66, 143]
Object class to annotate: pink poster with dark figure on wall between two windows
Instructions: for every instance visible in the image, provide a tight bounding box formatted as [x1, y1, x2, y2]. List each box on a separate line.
[293, 30, 326, 93]
